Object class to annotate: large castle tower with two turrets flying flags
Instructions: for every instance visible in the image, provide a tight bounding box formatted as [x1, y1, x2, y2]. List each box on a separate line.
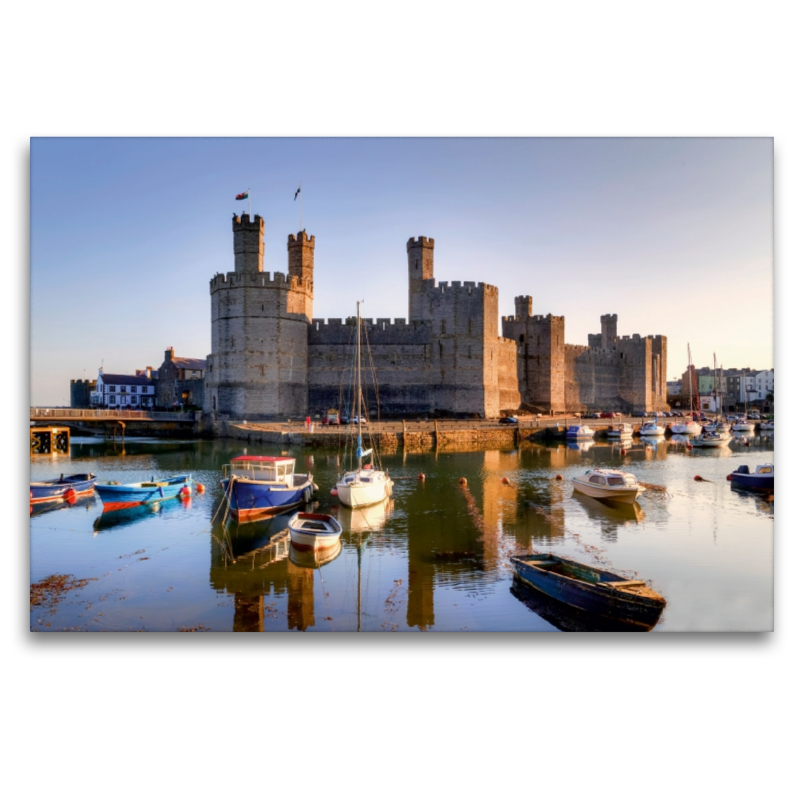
[203, 214, 314, 420]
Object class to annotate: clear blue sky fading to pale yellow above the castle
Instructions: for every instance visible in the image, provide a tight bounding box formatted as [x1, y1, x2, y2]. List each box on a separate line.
[31, 138, 773, 405]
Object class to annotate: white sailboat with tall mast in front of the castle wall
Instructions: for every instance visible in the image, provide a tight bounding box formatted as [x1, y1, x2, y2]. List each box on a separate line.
[336, 302, 394, 508]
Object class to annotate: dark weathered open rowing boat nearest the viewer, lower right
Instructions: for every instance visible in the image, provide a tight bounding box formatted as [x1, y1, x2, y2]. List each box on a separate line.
[511, 553, 666, 630]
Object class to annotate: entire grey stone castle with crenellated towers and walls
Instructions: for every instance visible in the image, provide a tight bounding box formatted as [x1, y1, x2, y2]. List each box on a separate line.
[203, 214, 667, 420]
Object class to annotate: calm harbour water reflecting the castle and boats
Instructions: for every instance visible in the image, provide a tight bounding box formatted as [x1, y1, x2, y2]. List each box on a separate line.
[30, 437, 774, 631]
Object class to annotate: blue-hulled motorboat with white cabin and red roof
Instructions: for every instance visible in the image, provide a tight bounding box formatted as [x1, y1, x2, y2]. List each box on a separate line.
[222, 456, 317, 519]
